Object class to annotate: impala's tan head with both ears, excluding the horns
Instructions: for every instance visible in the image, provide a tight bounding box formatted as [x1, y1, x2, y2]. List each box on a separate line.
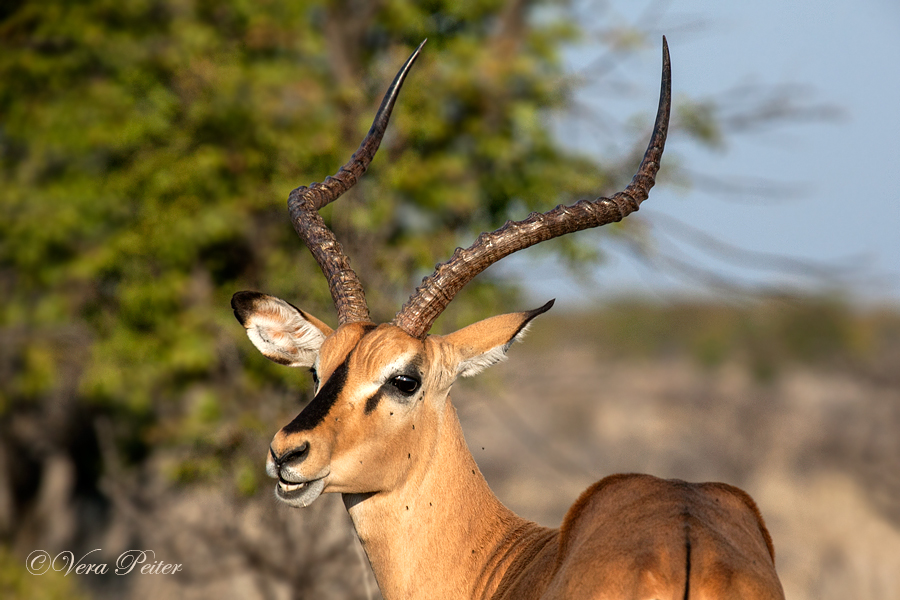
[233, 292, 551, 506]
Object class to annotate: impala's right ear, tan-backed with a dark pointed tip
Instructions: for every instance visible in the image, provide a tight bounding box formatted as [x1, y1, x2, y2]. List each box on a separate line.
[444, 300, 555, 377]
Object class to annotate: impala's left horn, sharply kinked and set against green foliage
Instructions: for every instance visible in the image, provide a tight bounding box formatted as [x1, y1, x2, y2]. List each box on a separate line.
[288, 40, 428, 324]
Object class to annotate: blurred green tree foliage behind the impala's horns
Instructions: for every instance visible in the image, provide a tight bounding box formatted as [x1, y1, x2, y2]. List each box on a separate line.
[0, 0, 608, 492]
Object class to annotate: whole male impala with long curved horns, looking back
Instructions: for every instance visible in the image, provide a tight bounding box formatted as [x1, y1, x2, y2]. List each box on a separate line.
[232, 38, 784, 600]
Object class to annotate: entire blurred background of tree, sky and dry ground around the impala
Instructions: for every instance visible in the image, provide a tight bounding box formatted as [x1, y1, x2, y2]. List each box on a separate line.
[0, 0, 900, 599]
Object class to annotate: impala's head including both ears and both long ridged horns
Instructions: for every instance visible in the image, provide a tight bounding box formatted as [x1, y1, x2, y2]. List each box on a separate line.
[232, 39, 670, 506]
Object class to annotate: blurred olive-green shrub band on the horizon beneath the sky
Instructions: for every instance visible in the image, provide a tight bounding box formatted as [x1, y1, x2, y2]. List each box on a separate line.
[540, 297, 900, 380]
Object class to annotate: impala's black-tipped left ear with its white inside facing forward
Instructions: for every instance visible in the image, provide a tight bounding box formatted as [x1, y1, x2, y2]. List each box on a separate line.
[231, 292, 332, 367]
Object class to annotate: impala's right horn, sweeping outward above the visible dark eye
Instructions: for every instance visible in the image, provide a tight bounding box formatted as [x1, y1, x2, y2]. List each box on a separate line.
[392, 37, 672, 338]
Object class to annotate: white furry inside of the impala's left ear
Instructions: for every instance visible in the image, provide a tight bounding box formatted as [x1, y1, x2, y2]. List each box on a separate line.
[245, 302, 325, 367]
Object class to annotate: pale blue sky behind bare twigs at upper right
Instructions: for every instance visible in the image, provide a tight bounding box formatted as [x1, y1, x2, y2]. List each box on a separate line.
[510, 0, 900, 306]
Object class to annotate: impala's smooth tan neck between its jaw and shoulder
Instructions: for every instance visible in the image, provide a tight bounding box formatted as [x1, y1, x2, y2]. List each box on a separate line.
[344, 400, 553, 600]
